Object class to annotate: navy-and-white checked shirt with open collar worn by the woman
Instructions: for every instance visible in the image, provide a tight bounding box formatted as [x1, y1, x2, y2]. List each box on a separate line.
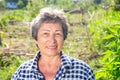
[11, 52, 94, 80]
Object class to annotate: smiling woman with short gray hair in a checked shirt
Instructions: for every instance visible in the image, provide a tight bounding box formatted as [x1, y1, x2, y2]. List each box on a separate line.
[12, 8, 94, 80]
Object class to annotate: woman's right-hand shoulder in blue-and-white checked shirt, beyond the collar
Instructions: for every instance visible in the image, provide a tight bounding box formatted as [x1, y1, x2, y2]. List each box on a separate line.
[61, 55, 94, 80]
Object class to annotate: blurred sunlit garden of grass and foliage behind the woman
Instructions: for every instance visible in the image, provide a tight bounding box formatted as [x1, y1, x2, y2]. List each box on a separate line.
[0, 0, 120, 80]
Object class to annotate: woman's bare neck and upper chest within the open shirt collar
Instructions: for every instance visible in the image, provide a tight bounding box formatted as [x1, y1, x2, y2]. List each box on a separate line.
[38, 55, 61, 80]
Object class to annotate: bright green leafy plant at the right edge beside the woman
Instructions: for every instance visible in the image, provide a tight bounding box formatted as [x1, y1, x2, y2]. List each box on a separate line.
[96, 25, 120, 80]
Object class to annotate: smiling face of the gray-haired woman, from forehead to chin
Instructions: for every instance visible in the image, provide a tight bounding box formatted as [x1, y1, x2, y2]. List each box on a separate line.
[36, 23, 64, 56]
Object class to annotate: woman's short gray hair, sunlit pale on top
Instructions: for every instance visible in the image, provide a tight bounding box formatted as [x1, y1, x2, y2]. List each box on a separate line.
[31, 8, 68, 40]
